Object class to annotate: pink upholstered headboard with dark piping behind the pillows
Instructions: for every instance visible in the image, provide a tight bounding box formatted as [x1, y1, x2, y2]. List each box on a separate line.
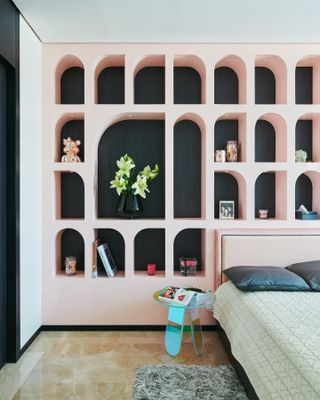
[215, 229, 320, 288]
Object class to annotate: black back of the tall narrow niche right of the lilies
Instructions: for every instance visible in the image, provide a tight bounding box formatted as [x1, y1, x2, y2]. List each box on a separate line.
[174, 120, 201, 218]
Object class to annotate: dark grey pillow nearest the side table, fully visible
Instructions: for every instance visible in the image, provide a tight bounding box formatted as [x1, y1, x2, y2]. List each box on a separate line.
[223, 266, 311, 291]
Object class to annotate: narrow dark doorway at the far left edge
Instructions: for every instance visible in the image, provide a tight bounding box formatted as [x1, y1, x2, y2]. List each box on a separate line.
[0, 62, 7, 368]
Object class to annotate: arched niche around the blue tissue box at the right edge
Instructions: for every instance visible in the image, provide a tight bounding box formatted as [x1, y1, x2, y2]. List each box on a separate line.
[295, 171, 320, 214]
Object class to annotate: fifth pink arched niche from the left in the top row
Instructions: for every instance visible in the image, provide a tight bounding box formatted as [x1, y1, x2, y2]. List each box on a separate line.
[214, 55, 247, 104]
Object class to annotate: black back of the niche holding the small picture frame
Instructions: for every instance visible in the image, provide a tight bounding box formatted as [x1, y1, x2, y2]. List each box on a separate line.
[214, 172, 239, 219]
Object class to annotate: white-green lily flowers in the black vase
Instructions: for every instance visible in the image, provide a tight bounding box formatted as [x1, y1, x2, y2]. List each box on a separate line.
[110, 154, 159, 199]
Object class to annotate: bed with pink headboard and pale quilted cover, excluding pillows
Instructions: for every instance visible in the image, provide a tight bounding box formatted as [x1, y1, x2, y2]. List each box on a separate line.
[214, 231, 320, 400]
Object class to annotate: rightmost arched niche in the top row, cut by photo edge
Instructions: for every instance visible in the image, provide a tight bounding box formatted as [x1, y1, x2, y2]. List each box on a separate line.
[295, 55, 320, 104]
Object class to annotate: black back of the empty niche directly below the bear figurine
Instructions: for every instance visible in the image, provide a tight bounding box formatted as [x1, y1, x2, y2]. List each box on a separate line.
[61, 172, 84, 218]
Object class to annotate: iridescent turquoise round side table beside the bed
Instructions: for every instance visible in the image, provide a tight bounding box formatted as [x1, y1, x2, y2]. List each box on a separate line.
[153, 290, 213, 356]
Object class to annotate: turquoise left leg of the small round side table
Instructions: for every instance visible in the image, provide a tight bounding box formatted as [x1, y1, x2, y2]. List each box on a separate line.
[165, 306, 184, 356]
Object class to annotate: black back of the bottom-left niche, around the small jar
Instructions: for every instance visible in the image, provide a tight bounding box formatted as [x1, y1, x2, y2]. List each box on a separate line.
[60, 229, 84, 271]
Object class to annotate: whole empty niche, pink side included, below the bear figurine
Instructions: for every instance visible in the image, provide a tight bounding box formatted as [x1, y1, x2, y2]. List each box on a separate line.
[55, 171, 84, 219]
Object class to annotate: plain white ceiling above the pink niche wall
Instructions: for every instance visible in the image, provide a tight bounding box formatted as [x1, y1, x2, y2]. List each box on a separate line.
[13, 0, 320, 43]
